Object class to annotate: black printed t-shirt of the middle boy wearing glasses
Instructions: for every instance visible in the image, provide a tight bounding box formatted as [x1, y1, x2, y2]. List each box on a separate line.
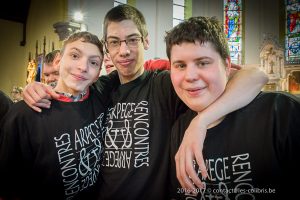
[98, 71, 186, 200]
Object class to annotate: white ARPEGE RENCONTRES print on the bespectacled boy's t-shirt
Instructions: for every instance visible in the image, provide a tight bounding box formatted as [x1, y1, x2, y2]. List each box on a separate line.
[104, 101, 149, 168]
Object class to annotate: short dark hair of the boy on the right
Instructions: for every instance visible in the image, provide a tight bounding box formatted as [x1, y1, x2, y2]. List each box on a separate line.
[165, 17, 230, 61]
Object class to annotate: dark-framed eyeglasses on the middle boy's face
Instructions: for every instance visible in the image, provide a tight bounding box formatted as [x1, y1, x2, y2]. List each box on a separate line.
[106, 36, 143, 50]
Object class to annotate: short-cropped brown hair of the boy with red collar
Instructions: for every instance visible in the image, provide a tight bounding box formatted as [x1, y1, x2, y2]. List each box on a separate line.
[61, 31, 104, 57]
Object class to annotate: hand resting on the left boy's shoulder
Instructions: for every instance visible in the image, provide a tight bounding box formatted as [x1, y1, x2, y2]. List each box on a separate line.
[23, 82, 59, 112]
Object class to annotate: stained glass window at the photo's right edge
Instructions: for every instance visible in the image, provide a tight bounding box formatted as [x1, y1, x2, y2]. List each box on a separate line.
[285, 0, 300, 64]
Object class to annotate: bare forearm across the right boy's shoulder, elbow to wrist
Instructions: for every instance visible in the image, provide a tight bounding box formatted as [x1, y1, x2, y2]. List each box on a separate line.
[199, 67, 268, 126]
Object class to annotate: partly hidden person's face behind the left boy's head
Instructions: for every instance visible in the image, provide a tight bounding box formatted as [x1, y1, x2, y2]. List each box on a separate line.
[43, 50, 60, 87]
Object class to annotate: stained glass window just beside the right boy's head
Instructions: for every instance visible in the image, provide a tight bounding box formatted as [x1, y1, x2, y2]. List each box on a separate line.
[224, 0, 243, 64]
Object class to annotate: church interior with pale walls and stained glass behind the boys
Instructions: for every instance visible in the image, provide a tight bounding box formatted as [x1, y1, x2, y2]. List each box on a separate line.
[0, 0, 300, 100]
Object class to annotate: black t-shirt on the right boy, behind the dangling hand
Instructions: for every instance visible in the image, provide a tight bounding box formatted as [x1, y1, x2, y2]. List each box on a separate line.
[171, 93, 300, 199]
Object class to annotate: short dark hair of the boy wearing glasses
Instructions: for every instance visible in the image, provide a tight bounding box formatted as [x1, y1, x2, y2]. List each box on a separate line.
[102, 4, 148, 40]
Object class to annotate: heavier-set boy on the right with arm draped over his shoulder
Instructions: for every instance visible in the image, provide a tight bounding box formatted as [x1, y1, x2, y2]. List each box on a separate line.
[165, 17, 300, 200]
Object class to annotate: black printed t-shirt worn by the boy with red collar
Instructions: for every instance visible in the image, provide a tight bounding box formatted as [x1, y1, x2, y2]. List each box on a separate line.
[0, 89, 107, 200]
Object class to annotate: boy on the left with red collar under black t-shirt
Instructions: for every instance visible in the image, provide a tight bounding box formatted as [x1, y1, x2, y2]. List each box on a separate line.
[0, 32, 111, 200]
